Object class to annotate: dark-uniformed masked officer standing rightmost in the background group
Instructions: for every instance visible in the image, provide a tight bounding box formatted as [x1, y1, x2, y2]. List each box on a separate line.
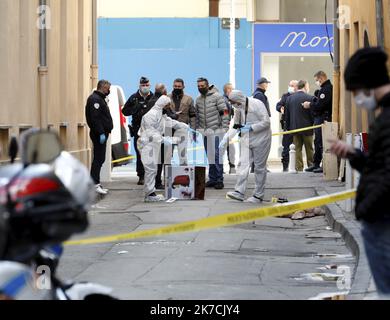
[304, 71, 333, 173]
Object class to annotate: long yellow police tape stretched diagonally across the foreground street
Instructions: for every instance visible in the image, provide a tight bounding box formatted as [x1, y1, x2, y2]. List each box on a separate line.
[64, 190, 356, 246]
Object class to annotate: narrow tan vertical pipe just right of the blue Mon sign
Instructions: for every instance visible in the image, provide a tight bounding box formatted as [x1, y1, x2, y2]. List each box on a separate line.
[332, 0, 341, 127]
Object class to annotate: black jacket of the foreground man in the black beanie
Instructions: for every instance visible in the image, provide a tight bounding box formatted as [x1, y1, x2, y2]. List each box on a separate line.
[349, 94, 390, 222]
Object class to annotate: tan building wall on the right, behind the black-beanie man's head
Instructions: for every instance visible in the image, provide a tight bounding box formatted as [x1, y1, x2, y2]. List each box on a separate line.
[333, 0, 390, 137]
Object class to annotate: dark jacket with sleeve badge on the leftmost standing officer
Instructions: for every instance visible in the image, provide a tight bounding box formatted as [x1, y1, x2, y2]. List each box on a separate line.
[85, 91, 114, 137]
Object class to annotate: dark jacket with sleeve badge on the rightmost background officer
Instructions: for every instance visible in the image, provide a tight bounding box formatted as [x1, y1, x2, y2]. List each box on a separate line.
[310, 80, 333, 121]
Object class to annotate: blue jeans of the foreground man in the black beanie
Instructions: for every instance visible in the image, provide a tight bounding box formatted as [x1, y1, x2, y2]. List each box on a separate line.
[362, 217, 390, 295]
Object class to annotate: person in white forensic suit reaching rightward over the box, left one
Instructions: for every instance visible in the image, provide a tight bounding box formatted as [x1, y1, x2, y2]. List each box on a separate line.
[137, 95, 198, 202]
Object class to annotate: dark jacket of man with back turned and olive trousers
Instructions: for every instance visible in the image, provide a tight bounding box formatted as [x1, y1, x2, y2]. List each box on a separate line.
[285, 91, 314, 136]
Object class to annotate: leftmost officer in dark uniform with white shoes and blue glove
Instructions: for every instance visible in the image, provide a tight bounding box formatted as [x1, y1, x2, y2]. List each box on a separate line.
[85, 80, 114, 195]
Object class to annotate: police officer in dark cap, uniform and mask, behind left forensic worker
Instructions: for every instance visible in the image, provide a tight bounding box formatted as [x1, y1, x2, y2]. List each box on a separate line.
[122, 77, 153, 185]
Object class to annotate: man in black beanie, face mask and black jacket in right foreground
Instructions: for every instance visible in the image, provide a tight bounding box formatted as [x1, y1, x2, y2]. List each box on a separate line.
[331, 48, 390, 297]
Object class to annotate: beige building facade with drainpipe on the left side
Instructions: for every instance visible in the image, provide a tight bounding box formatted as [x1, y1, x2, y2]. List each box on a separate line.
[0, 0, 96, 164]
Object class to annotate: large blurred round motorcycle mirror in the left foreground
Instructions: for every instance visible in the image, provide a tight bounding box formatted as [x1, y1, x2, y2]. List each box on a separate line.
[22, 131, 63, 165]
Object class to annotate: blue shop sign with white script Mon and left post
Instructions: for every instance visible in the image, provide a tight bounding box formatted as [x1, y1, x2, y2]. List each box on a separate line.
[254, 23, 334, 86]
